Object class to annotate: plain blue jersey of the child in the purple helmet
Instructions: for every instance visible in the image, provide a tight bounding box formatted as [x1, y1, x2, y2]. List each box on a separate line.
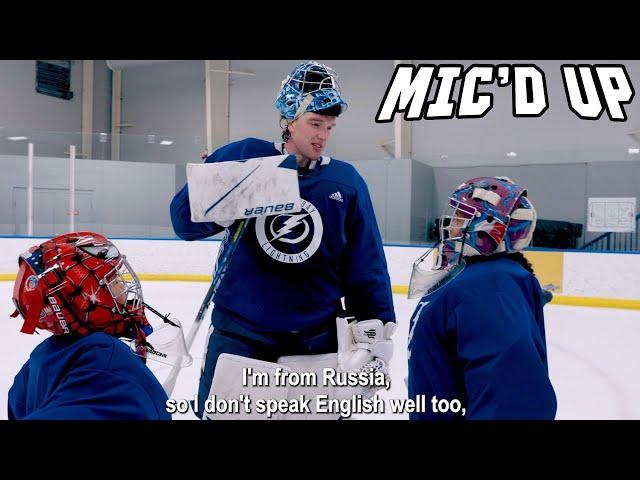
[408, 257, 556, 419]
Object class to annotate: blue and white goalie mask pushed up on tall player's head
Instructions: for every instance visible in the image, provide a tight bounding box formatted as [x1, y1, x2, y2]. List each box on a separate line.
[275, 62, 347, 122]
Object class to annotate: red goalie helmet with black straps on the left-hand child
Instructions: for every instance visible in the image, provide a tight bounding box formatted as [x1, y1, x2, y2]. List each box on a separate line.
[12, 232, 150, 345]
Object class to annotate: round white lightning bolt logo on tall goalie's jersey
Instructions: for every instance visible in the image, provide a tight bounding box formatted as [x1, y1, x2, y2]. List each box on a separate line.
[256, 200, 322, 263]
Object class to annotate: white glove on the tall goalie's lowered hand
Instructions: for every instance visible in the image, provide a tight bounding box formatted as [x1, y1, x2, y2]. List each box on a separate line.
[336, 317, 397, 398]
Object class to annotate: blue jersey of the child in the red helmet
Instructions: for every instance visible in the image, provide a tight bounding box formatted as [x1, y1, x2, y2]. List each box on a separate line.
[8, 333, 171, 420]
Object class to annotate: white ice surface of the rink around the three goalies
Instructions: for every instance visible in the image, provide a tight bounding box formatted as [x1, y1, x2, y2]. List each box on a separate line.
[0, 282, 640, 419]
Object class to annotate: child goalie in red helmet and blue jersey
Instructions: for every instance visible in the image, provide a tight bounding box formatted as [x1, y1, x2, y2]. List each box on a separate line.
[8, 232, 190, 420]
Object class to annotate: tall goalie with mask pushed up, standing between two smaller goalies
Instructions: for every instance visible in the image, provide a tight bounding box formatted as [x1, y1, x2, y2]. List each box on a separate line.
[171, 62, 395, 416]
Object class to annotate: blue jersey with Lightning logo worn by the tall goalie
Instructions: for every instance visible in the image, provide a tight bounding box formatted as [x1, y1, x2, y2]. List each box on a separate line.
[171, 138, 395, 332]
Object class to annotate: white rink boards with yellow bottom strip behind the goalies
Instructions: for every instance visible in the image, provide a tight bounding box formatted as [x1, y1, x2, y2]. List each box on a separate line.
[0, 237, 640, 310]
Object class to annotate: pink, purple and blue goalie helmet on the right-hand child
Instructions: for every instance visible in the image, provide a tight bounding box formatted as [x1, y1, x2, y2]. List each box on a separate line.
[435, 177, 536, 269]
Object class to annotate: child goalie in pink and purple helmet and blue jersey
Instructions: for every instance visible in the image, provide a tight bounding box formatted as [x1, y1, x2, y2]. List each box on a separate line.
[408, 177, 556, 420]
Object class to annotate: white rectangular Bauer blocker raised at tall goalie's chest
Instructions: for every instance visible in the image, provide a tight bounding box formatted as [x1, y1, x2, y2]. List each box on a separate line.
[187, 155, 302, 225]
